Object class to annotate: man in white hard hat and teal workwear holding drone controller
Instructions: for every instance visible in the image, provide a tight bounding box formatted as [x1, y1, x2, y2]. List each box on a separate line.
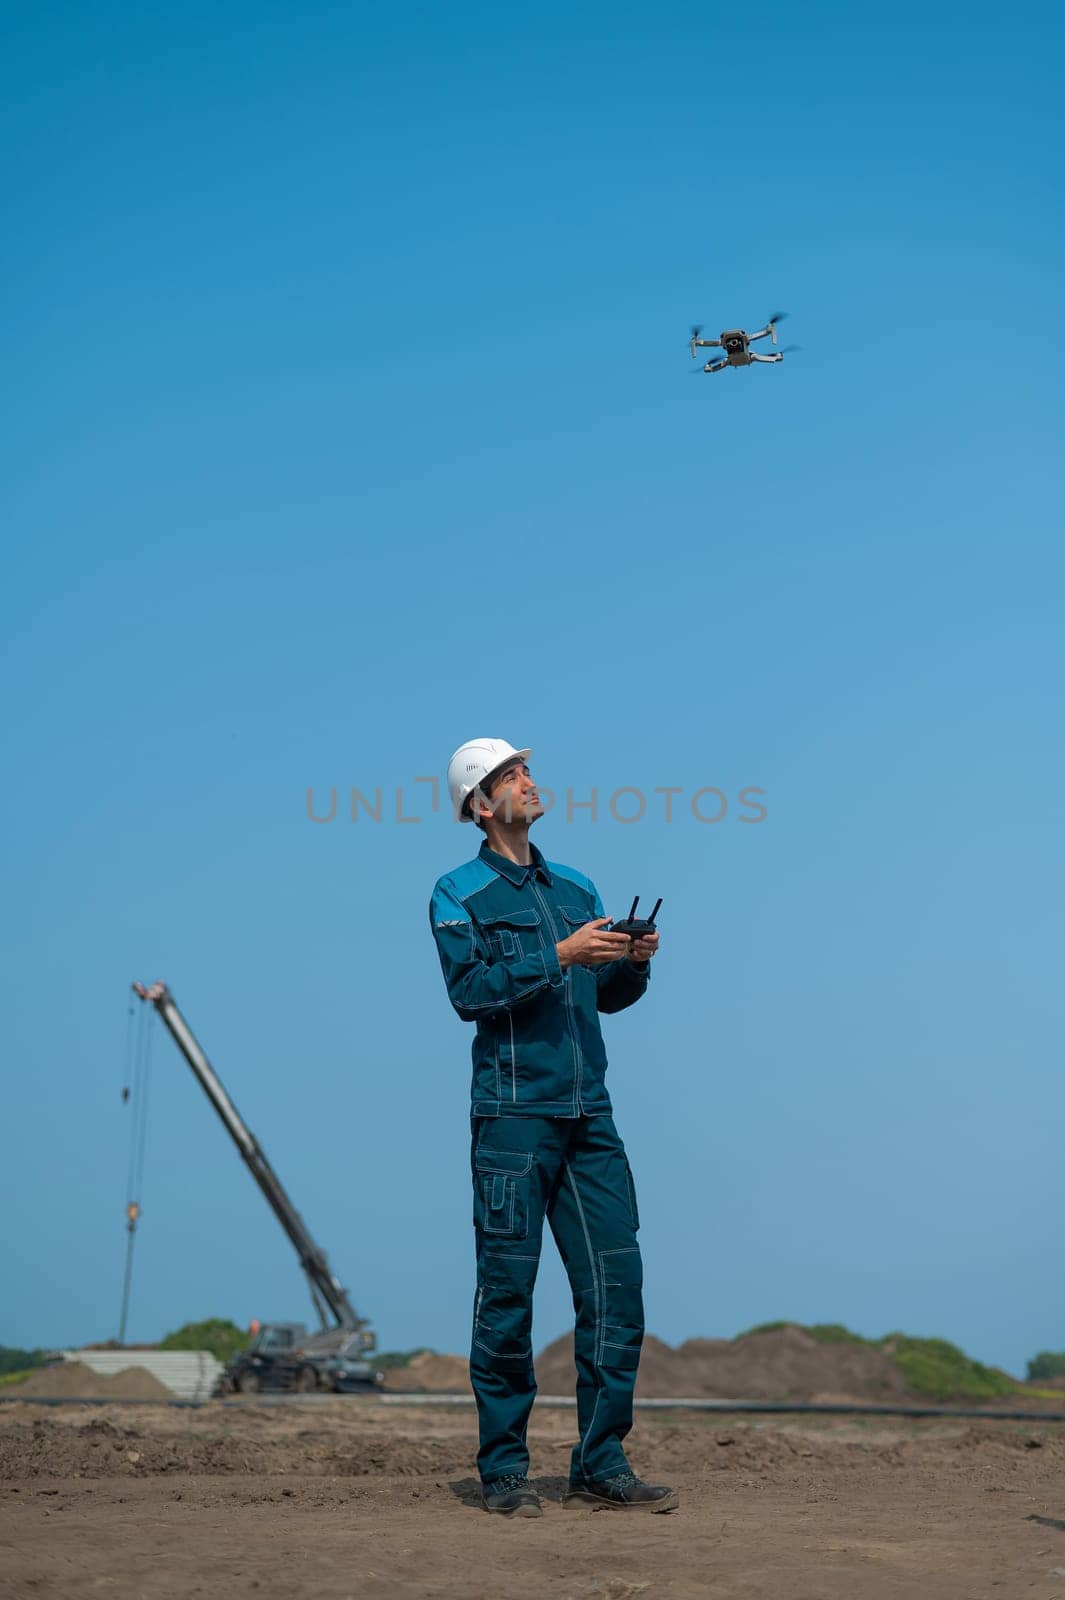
[430, 739, 678, 1517]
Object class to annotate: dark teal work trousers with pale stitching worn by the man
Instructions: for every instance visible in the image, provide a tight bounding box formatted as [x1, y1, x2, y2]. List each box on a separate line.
[470, 1117, 643, 1483]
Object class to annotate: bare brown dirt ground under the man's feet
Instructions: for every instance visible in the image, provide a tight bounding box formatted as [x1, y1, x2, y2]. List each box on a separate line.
[0, 1397, 1065, 1600]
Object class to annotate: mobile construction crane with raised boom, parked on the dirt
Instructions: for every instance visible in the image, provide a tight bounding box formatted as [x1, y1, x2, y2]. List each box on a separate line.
[133, 982, 381, 1392]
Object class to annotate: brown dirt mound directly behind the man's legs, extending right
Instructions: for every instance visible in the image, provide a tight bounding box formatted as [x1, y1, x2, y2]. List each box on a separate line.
[536, 1326, 911, 1402]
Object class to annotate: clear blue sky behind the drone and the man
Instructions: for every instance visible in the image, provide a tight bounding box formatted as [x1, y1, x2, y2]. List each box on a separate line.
[0, 0, 1065, 1371]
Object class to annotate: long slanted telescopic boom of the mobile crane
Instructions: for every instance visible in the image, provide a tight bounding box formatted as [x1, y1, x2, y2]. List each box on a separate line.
[133, 984, 374, 1349]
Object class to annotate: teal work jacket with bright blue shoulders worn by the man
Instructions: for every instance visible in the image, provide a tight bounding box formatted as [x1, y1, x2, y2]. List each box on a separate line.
[429, 843, 649, 1117]
